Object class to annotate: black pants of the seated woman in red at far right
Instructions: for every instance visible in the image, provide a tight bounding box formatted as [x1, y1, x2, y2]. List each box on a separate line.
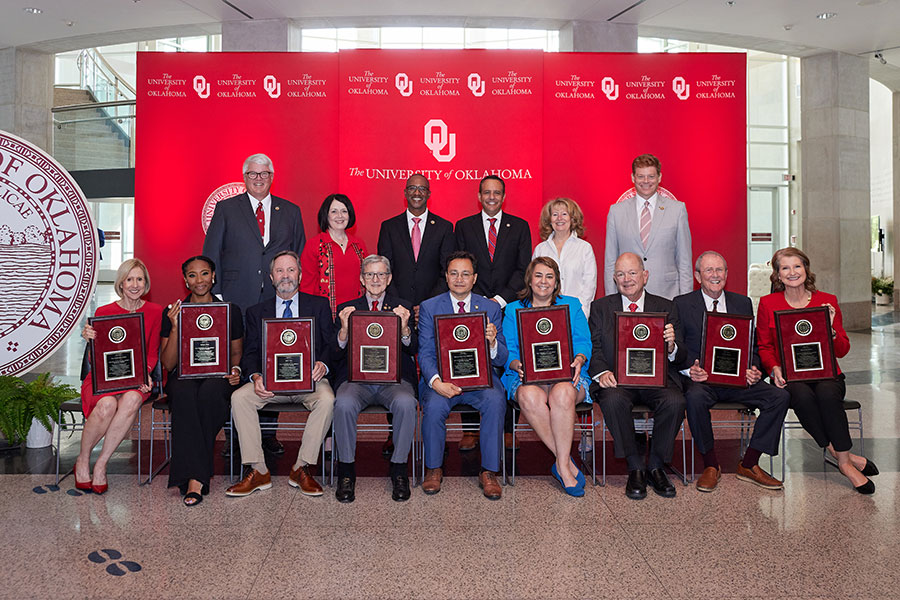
[785, 374, 853, 452]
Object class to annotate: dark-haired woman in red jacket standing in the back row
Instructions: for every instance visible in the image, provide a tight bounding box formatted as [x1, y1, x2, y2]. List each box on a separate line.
[300, 194, 368, 318]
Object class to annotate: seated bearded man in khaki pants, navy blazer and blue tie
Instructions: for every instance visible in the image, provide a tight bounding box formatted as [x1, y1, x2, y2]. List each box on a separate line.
[225, 250, 334, 496]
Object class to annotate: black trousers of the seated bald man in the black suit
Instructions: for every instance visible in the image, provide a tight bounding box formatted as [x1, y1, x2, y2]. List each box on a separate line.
[590, 381, 684, 464]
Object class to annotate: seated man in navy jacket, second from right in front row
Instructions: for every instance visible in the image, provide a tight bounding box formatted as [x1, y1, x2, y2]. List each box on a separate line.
[675, 251, 791, 492]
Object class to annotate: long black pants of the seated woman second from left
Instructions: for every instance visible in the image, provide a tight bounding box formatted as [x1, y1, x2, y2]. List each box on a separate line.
[166, 375, 232, 492]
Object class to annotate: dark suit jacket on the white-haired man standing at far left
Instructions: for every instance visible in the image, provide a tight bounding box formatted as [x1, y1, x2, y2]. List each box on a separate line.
[203, 192, 306, 320]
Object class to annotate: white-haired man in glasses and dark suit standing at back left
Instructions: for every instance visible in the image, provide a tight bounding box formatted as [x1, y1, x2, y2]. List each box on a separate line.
[203, 154, 306, 454]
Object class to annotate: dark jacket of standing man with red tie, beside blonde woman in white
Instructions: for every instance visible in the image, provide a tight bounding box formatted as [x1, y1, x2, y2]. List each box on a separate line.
[455, 211, 531, 303]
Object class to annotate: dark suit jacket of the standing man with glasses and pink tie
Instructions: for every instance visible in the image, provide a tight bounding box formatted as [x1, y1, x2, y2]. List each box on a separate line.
[378, 210, 456, 306]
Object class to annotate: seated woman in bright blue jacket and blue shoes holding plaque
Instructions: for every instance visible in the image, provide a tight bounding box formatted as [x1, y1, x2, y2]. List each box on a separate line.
[503, 256, 591, 497]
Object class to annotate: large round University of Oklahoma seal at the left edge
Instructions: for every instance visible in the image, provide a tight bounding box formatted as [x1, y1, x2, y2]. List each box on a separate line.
[0, 131, 98, 375]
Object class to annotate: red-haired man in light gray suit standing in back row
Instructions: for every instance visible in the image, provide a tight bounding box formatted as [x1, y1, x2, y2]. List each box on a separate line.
[603, 154, 694, 300]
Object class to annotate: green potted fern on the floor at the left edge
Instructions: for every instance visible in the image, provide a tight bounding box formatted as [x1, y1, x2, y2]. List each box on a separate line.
[0, 373, 79, 447]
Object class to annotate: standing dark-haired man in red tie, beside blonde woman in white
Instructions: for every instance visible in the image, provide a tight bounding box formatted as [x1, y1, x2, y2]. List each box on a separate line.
[455, 175, 531, 451]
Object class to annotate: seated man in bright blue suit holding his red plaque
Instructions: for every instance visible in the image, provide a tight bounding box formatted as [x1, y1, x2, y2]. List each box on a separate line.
[419, 250, 508, 500]
